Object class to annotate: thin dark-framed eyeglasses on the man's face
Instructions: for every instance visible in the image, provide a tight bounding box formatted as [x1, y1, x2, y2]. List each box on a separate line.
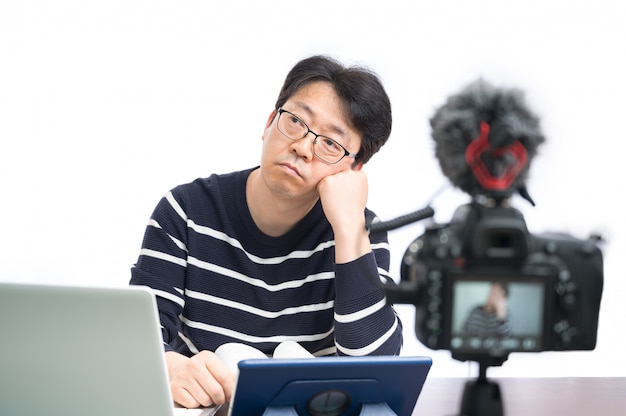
[277, 108, 357, 165]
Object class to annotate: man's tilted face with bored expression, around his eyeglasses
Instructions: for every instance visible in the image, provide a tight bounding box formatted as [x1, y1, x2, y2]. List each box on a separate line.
[261, 81, 361, 199]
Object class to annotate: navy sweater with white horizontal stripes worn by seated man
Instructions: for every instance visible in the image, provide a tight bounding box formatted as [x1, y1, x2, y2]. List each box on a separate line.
[130, 169, 402, 356]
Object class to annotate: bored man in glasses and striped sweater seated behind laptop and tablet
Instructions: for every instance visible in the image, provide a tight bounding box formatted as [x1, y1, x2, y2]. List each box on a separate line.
[131, 56, 402, 407]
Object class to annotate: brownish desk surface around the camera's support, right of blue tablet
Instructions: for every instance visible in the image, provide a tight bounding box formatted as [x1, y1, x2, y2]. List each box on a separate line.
[413, 377, 626, 416]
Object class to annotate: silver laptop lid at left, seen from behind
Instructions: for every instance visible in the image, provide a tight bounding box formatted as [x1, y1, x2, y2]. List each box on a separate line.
[0, 282, 215, 416]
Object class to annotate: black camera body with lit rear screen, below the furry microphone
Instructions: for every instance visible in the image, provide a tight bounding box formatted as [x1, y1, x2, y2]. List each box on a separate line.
[386, 199, 603, 365]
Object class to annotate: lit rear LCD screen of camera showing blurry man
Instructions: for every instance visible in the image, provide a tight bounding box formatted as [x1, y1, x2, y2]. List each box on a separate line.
[450, 276, 546, 354]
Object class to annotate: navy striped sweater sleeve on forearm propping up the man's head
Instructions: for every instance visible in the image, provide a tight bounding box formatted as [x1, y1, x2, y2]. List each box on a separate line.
[335, 248, 402, 356]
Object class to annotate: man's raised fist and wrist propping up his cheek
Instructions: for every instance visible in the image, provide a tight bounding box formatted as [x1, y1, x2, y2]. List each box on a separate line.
[317, 170, 371, 263]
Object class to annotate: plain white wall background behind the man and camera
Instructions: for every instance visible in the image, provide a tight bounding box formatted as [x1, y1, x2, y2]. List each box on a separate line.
[0, 0, 626, 376]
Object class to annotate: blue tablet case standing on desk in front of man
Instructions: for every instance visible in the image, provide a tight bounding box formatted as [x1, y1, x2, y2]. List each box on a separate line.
[230, 356, 432, 416]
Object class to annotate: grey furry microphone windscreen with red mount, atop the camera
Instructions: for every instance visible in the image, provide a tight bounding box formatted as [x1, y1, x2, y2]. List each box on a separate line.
[430, 79, 545, 202]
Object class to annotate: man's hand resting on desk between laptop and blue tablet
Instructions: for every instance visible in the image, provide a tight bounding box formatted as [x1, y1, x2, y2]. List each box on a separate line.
[165, 351, 236, 409]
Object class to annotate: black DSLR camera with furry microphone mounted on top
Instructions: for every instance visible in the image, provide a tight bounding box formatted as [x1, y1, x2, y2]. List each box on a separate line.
[372, 79, 603, 366]
